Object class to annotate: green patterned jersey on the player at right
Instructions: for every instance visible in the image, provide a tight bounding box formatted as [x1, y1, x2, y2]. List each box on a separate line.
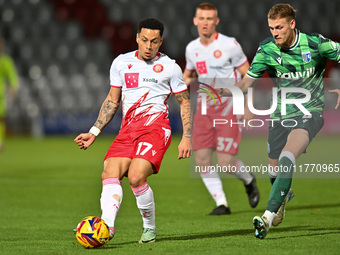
[247, 29, 340, 119]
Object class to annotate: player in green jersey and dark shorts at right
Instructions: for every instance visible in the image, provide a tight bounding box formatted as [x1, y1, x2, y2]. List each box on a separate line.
[220, 4, 340, 239]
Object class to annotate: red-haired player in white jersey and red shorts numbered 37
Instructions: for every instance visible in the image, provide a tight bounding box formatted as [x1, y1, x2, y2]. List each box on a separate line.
[183, 3, 259, 215]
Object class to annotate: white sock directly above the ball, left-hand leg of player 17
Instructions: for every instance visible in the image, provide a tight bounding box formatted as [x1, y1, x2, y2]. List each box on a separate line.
[100, 178, 123, 228]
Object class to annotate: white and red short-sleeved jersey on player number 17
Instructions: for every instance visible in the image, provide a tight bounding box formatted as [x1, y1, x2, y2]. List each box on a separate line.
[110, 51, 187, 126]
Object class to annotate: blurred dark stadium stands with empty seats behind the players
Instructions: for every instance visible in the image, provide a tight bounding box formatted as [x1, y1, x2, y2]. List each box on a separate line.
[0, 0, 340, 137]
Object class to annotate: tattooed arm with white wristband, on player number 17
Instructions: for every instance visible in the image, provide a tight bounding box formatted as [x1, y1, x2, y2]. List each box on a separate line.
[74, 87, 121, 150]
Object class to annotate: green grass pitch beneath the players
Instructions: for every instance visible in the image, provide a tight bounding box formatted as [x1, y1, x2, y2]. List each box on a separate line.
[0, 136, 340, 255]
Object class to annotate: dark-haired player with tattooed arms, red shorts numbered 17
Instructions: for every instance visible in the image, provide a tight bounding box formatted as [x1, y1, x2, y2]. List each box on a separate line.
[75, 18, 192, 243]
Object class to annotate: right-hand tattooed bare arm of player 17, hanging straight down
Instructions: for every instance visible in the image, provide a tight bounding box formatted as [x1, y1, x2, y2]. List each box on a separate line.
[175, 90, 192, 159]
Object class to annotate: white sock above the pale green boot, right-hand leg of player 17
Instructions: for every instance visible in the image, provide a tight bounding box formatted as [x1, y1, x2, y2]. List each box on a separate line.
[131, 182, 156, 229]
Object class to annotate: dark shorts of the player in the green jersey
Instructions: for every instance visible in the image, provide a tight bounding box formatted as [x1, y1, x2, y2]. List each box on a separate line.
[268, 112, 324, 159]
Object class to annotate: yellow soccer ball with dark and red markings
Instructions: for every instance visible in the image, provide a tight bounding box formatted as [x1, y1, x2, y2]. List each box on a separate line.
[76, 216, 110, 248]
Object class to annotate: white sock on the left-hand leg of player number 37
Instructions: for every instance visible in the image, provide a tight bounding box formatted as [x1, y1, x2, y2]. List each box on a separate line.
[201, 171, 228, 207]
